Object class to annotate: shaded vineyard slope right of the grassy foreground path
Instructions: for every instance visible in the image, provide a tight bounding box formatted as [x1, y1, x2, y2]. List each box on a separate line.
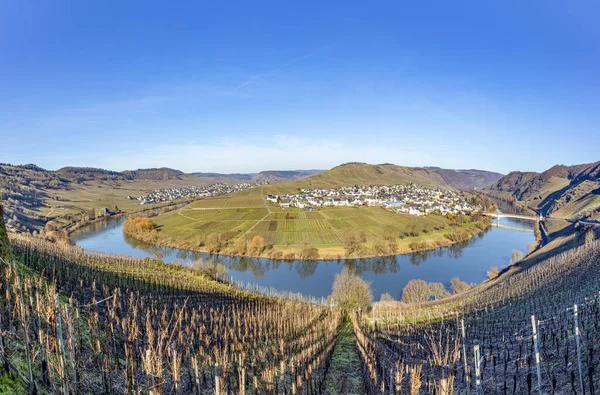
[355, 241, 600, 394]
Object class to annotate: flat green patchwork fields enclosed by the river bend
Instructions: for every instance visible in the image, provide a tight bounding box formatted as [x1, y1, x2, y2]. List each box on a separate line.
[146, 187, 488, 256]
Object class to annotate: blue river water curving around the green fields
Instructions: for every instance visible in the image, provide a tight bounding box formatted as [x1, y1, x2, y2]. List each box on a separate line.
[72, 212, 535, 300]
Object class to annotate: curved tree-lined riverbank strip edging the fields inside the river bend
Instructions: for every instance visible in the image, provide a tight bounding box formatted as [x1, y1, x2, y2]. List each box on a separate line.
[123, 217, 491, 261]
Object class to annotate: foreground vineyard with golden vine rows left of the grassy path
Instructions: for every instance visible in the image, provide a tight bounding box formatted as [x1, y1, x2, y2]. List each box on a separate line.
[0, 237, 339, 394]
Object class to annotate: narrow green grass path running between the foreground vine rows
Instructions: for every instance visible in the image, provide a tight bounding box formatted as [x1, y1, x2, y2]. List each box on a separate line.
[324, 322, 365, 395]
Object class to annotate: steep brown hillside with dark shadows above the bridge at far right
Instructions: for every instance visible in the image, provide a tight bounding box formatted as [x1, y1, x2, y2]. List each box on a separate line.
[484, 162, 600, 219]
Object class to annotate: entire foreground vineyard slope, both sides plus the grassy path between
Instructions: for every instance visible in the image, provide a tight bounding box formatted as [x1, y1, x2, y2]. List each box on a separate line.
[0, 200, 600, 395]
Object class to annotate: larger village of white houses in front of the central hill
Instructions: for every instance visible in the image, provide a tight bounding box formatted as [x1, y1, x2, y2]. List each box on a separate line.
[267, 184, 480, 216]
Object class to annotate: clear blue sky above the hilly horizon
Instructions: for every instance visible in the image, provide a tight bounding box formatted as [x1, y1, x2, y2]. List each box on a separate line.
[0, 0, 600, 173]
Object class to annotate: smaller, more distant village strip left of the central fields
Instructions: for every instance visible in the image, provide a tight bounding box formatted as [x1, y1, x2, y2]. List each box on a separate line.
[136, 180, 268, 204]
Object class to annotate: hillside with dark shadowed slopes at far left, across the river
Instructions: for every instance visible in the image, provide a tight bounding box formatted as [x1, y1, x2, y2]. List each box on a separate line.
[0, 164, 215, 232]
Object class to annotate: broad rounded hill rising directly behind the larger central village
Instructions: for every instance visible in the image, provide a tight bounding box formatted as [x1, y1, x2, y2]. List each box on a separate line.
[274, 163, 502, 189]
